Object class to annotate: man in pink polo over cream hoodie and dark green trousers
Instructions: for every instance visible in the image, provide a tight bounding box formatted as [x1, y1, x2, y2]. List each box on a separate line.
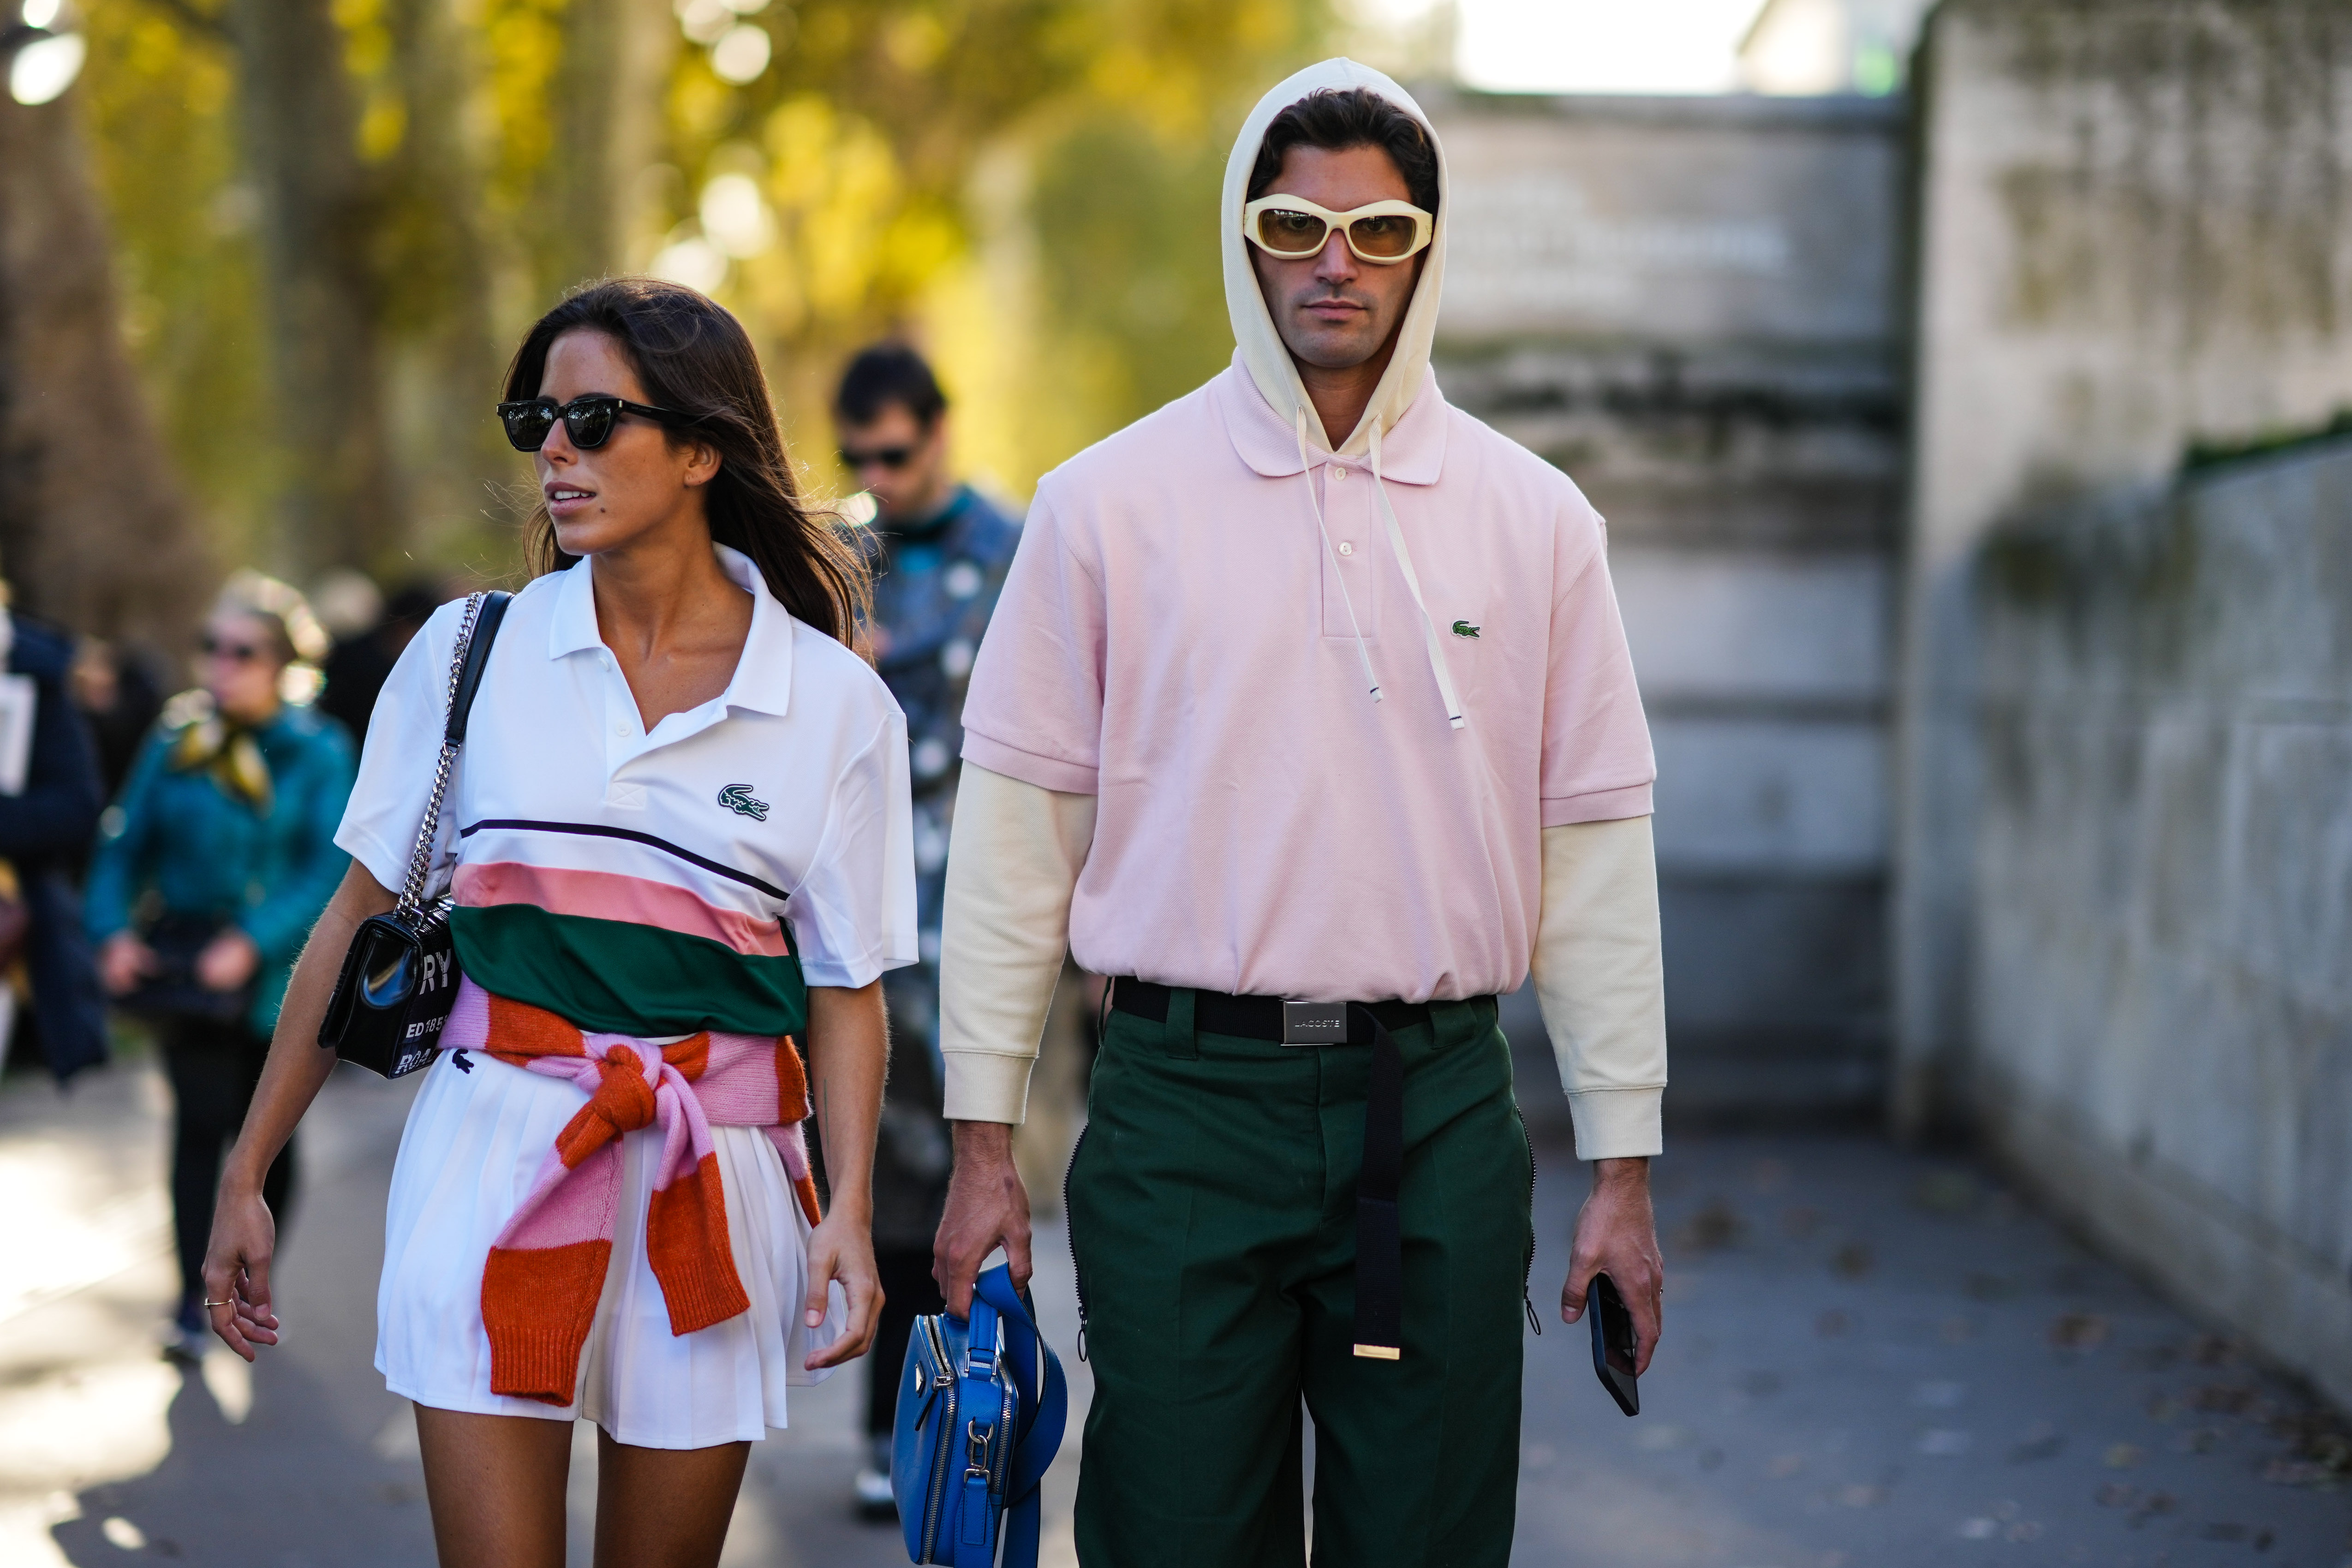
[936, 61, 1665, 1568]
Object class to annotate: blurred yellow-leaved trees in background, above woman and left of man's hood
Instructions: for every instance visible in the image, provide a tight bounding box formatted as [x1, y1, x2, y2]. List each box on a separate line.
[64, 0, 1326, 576]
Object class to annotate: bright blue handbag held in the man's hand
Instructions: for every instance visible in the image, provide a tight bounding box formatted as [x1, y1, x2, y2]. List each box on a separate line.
[889, 1265, 1070, 1568]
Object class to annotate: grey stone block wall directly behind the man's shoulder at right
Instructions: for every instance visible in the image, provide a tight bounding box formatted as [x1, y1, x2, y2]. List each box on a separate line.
[1433, 96, 1905, 1119]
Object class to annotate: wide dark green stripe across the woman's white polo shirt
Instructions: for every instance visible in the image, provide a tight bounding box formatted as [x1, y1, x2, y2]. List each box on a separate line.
[449, 903, 809, 1037]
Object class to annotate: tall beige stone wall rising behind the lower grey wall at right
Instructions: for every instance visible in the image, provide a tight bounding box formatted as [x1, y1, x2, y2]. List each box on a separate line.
[1893, 0, 2352, 1128]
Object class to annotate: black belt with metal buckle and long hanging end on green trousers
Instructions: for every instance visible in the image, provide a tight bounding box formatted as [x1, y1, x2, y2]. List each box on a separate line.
[1110, 978, 1430, 1361]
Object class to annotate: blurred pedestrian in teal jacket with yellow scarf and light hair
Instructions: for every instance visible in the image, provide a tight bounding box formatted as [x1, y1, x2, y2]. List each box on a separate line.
[85, 571, 353, 1356]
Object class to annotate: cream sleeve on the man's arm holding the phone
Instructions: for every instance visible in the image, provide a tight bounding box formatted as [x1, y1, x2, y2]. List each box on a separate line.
[1534, 816, 1665, 1159]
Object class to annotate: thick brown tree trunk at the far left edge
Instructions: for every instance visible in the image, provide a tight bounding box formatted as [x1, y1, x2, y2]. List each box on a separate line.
[0, 92, 209, 639]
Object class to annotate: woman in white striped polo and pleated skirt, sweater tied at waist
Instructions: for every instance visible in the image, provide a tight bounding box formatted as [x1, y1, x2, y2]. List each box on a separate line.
[205, 280, 915, 1568]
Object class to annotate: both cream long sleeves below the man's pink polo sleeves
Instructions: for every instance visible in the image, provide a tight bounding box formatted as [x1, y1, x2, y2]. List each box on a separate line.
[938, 762, 1665, 1159]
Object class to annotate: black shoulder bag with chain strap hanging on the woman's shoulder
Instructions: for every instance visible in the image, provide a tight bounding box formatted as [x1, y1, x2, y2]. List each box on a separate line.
[317, 592, 513, 1079]
